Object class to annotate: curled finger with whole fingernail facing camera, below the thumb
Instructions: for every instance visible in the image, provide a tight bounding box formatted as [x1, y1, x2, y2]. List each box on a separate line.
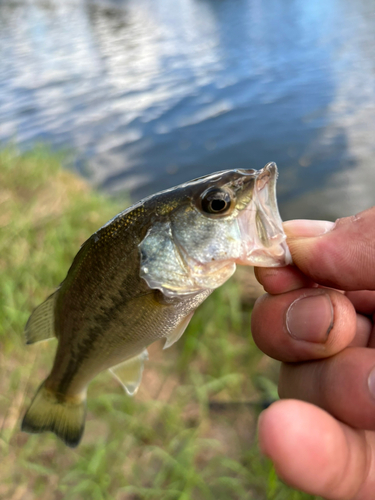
[251, 288, 362, 362]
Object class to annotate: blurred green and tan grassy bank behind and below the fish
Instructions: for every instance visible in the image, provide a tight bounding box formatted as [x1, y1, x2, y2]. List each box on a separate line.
[0, 148, 324, 500]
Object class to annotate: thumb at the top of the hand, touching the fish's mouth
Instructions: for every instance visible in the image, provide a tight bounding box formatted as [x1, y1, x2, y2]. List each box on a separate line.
[284, 207, 375, 290]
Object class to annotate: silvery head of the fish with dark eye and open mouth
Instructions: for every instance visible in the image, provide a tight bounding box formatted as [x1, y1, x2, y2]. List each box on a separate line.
[140, 163, 291, 296]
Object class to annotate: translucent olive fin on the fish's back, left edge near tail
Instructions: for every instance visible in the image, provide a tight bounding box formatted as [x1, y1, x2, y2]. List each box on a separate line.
[25, 290, 58, 344]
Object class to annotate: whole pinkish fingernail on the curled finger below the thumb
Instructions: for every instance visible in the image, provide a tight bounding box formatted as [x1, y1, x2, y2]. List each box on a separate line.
[286, 293, 333, 344]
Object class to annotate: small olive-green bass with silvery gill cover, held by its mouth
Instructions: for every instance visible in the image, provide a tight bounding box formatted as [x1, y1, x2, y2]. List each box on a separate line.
[21, 162, 291, 447]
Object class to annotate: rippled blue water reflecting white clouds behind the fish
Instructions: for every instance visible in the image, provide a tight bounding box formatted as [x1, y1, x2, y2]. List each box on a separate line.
[0, 0, 375, 218]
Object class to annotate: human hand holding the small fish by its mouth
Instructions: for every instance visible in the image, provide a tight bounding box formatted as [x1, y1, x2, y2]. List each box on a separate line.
[252, 207, 375, 500]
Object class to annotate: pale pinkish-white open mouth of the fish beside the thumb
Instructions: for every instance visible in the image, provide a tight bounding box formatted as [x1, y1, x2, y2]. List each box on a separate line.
[236, 162, 292, 267]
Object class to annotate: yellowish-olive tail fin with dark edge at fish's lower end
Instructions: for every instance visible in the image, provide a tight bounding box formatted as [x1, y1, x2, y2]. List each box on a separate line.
[21, 383, 86, 448]
